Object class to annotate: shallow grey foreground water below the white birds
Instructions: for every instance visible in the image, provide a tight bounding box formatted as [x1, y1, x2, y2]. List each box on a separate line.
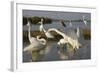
[23, 30, 91, 62]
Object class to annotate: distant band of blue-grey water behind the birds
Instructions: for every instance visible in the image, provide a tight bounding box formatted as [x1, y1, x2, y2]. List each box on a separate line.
[23, 21, 91, 31]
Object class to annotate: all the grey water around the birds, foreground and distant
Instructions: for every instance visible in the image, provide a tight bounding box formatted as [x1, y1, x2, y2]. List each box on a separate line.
[23, 22, 91, 62]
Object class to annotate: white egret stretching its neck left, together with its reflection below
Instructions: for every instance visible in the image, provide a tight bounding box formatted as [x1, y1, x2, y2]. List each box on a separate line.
[48, 28, 81, 59]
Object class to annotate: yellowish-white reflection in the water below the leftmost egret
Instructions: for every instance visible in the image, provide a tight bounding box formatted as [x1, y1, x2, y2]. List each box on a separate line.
[23, 42, 52, 62]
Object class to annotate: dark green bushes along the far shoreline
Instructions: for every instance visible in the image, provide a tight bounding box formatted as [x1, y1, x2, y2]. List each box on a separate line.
[23, 16, 91, 25]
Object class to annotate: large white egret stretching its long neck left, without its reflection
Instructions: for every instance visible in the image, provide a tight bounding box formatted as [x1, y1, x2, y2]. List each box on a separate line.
[48, 28, 81, 49]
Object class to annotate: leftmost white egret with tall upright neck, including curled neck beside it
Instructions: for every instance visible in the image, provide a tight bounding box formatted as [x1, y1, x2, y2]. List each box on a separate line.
[24, 21, 46, 52]
